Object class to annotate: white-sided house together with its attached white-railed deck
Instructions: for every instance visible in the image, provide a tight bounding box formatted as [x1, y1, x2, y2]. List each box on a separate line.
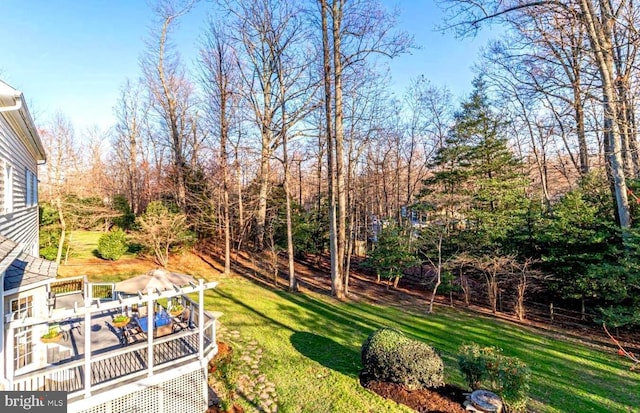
[0, 81, 219, 413]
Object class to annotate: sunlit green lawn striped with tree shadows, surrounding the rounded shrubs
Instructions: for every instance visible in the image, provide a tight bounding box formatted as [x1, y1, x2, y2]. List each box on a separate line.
[206, 277, 640, 412]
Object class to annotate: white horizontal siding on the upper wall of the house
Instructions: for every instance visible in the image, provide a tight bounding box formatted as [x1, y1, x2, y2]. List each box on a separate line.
[0, 113, 38, 256]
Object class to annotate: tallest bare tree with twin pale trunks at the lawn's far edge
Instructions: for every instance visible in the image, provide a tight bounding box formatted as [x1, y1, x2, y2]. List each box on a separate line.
[318, 0, 411, 298]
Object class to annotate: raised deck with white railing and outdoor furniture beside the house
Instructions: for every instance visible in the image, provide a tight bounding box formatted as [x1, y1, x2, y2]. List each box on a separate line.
[6, 278, 221, 404]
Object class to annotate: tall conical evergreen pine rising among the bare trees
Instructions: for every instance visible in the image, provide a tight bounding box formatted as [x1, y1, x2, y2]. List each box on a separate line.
[423, 77, 528, 253]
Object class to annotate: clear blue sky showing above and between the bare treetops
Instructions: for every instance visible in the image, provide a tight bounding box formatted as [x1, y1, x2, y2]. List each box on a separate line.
[0, 0, 496, 132]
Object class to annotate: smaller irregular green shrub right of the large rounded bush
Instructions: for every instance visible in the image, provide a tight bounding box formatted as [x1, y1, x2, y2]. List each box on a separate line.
[458, 343, 531, 412]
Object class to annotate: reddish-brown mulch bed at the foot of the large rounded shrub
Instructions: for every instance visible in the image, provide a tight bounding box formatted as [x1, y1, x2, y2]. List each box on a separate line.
[363, 381, 466, 413]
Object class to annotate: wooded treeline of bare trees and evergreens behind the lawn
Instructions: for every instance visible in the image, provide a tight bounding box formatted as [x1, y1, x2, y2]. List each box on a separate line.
[41, 0, 640, 325]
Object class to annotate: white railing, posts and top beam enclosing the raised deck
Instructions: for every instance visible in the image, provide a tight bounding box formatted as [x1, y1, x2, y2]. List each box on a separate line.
[6, 277, 221, 399]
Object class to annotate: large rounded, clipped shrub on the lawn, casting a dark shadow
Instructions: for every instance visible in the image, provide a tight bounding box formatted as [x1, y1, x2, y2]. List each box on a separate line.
[361, 328, 444, 390]
